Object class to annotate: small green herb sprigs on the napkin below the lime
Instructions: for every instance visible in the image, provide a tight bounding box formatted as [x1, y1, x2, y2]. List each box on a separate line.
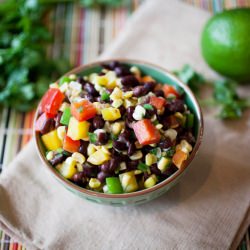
[174, 65, 250, 119]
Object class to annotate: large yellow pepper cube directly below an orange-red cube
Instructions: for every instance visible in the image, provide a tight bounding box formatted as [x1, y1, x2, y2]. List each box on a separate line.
[67, 116, 90, 140]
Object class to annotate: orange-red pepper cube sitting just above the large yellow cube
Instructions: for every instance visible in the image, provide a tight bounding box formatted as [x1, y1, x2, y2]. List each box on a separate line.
[71, 99, 97, 122]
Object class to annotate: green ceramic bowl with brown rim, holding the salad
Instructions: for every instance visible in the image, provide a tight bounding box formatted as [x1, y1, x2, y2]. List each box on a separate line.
[35, 59, 203, 206]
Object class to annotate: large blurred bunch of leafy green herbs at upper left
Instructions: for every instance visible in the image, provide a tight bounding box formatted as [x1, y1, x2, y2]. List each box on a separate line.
[0, 0, 69, 111]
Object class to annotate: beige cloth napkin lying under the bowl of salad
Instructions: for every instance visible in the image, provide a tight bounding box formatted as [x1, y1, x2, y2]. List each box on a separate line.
[0, 0, 250, 250]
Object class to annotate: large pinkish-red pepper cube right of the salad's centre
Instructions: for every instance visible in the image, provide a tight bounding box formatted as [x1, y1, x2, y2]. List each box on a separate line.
[133, 119, 161, 145]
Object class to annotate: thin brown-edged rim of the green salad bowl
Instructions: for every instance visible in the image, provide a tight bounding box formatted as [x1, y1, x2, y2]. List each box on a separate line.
[33, 58, 204, 199]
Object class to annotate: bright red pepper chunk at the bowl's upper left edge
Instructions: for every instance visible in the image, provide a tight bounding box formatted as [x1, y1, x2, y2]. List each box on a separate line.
[41, 88, 64, 115]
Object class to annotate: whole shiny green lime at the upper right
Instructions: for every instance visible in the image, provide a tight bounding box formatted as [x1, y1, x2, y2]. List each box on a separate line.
[201, 8, 250, 82]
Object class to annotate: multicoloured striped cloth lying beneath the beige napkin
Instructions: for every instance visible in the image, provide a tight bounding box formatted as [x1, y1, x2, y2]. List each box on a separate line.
[0, 0, 250, 250]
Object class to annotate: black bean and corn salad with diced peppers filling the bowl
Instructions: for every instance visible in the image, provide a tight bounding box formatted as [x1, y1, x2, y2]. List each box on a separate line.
[35, 61, 195, 194]
